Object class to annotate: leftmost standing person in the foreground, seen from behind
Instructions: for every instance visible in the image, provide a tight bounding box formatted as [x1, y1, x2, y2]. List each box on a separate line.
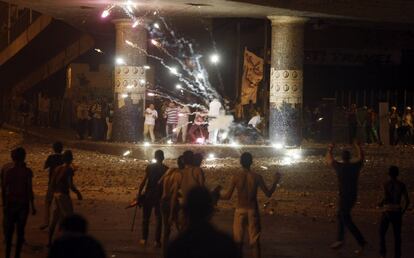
[1, 148, 36, 258]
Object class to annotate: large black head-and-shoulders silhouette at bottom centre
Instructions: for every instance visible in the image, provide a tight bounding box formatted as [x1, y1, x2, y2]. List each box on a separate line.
[164, 187, 241, 258]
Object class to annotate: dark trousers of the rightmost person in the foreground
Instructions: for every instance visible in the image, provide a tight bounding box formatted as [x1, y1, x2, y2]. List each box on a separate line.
[379, 211, 402, 258]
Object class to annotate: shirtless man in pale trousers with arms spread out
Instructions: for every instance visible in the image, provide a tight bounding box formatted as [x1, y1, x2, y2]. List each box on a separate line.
[221, 152, 281, 258]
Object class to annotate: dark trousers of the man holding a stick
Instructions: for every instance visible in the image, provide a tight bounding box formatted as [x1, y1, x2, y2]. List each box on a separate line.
[142, 203, 162, 243]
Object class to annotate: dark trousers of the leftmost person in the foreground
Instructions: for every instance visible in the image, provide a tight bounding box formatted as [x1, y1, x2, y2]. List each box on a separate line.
[4, 204, 29, 258]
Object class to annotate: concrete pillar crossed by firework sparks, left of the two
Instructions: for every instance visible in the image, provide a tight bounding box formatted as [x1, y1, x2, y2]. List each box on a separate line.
[112, 19, 147, 142]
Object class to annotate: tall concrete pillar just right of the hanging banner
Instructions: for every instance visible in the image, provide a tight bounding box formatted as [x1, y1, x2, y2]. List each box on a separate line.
[268, 16, 306, 146]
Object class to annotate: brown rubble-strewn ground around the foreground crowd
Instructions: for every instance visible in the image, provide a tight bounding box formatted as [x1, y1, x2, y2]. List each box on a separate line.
[0, 130, 414, 258]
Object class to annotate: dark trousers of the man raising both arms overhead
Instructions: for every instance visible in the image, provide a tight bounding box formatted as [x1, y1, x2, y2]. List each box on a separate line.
[337, 205, 366, 246]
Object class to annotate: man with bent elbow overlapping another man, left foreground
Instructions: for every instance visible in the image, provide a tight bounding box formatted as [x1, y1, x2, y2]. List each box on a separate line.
[48, 150, 83, 246]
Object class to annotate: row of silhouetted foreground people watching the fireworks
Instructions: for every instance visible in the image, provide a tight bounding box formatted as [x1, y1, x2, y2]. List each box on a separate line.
[1, 142, 409, 258]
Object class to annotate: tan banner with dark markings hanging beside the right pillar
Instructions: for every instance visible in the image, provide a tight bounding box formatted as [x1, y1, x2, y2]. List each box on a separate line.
[241, 48, 264, 105]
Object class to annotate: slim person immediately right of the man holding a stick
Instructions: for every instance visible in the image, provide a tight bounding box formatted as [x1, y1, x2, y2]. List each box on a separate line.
[159, 156, 184, 252]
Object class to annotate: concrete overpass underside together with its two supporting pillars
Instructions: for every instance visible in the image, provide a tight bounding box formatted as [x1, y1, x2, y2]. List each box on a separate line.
[1, 0, 414, 145]
